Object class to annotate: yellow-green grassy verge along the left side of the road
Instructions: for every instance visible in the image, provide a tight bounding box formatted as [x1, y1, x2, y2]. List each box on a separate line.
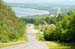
[0, 35, 27, 48]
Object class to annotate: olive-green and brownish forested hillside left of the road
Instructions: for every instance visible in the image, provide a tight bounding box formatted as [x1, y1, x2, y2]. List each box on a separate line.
[0, 0, 26, 43]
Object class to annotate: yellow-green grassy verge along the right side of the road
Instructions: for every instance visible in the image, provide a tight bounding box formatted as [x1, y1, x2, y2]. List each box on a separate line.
[36, 33, 75, 49]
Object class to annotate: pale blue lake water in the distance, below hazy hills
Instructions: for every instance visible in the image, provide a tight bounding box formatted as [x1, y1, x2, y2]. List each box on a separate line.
[12, 7, 49, 17]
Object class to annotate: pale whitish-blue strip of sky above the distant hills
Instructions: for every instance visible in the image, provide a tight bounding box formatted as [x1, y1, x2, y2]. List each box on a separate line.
[4, 0, 75, 4]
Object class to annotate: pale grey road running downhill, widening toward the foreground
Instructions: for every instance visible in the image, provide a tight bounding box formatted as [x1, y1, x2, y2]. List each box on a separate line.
[2, 25, 48, 49]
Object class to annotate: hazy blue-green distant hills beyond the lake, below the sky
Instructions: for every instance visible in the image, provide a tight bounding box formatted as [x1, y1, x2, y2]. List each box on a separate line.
[8, 3, 75, 14]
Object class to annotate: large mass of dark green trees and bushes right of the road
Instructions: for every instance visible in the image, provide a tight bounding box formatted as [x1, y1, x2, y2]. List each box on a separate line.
[44, 11, 75, 43]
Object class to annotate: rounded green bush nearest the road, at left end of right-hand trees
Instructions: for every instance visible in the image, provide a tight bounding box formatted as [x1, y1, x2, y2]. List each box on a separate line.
[44, 27, 58, 41]
